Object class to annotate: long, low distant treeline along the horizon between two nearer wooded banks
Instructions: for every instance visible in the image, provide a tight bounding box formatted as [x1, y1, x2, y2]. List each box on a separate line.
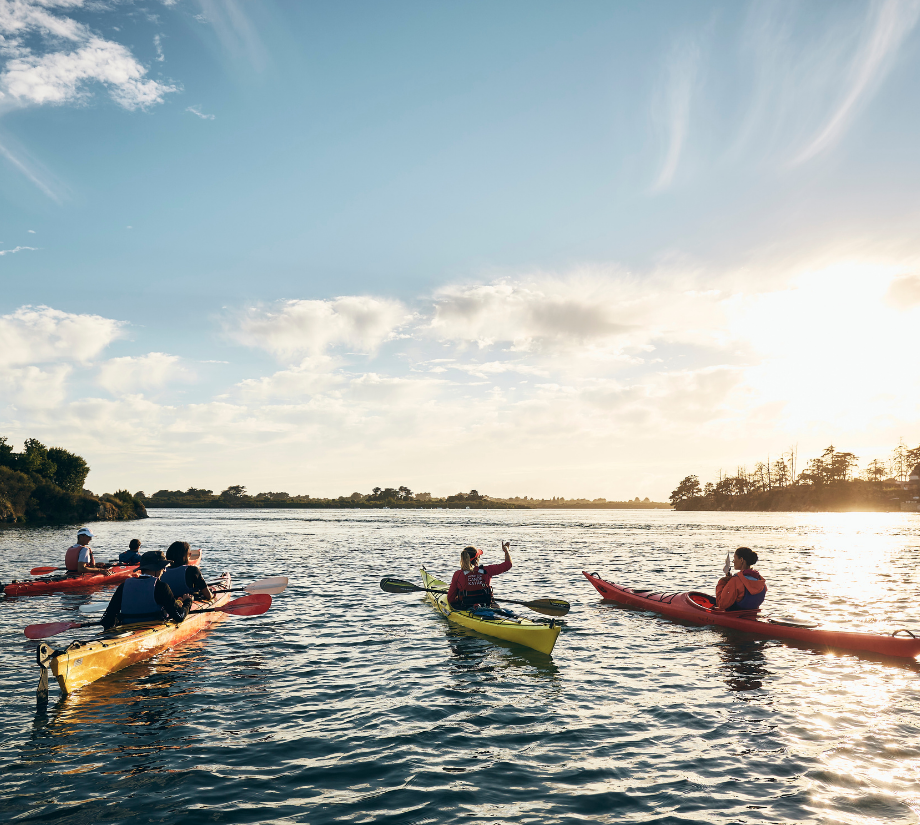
[144, 484, 671, 510]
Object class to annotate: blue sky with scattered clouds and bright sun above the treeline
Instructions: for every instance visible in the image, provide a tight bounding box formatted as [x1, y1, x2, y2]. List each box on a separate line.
[0, 0, 920, 500]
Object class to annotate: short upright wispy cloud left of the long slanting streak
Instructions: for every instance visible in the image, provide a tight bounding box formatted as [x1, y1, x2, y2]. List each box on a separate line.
[652, 39, 700, 192]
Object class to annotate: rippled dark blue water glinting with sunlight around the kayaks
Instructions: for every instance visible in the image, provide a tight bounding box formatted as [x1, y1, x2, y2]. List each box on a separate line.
[0, 510, 920, 825]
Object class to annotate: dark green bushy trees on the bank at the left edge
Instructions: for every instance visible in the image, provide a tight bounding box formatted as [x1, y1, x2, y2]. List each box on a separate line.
[0, 436, 147, 525]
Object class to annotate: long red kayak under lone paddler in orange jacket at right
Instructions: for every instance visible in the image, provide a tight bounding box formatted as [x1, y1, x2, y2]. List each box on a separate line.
[581, 570, 920, 659]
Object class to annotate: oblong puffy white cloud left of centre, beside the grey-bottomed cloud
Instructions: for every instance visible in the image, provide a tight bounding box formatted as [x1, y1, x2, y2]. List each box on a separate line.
[234, 295, 409, 358]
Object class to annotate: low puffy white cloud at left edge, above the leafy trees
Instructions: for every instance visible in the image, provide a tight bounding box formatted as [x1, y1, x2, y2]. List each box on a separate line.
[0, 306, 124, 366]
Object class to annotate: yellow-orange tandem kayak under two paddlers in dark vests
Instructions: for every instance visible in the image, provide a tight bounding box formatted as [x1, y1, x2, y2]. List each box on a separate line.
[38, 573, 230, 696]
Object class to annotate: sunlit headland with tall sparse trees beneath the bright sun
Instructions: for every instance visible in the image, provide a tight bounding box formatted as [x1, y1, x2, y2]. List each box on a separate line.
[670, 445, 920, 512]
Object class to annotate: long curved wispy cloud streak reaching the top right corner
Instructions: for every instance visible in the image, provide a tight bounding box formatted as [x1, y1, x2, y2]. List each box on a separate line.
[794, 0, 920, 163]
